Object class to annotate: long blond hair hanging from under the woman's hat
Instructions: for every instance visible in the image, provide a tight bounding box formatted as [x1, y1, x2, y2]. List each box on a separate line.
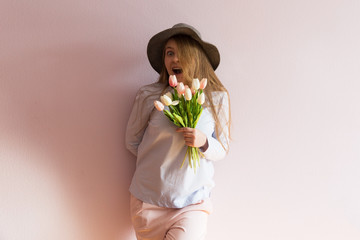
[158, 35, 231, 151]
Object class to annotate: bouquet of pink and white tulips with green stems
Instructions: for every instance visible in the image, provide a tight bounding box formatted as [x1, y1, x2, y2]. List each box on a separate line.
[154, 75, 207, 171]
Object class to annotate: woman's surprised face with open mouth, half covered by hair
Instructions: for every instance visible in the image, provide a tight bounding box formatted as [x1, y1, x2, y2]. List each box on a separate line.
[164, 39, 184, 82]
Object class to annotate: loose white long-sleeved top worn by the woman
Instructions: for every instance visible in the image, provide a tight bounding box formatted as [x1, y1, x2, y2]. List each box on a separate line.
[126, 83, 228, 208]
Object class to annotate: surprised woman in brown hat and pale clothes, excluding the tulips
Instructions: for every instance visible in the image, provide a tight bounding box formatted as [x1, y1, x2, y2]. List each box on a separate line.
[126, 23, 230, 240]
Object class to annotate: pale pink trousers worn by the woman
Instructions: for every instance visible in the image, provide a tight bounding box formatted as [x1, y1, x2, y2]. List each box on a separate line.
[130, 195, 212, 240]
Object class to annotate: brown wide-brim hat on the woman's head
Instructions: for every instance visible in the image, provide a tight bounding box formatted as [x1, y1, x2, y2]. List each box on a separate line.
[147, 23, 220, 73]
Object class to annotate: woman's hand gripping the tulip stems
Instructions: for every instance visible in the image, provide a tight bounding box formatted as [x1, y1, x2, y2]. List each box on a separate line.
[176, 127, 208, 152]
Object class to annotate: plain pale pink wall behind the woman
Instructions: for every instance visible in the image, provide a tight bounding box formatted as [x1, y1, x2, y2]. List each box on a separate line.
[0, 0, 360, 240]
